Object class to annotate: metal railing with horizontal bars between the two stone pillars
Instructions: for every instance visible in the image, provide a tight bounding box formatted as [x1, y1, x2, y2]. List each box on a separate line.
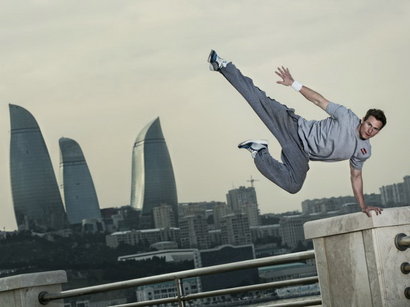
[38, 250, 321, 307]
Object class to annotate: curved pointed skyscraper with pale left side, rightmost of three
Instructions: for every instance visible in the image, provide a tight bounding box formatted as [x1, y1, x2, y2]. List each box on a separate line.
[131, 117, 178, 227]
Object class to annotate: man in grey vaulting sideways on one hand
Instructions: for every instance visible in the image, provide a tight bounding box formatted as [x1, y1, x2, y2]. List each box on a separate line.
[208, 50, 386, 216]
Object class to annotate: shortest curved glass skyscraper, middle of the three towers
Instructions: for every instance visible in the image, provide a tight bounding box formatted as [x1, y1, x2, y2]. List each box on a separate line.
[59, 138, 101, 224]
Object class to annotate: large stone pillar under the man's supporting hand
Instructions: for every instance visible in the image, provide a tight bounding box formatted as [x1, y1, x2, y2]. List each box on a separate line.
[304, 207, 410, 307]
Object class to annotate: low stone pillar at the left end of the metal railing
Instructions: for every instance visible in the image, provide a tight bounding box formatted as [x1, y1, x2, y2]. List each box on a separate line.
[0, 271, 67, 307]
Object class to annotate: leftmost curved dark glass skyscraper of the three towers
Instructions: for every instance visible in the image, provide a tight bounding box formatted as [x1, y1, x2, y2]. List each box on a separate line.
[9, 104, 66, 231]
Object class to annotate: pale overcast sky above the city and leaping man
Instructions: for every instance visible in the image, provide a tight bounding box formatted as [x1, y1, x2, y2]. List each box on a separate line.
[0, 0, 410, 230]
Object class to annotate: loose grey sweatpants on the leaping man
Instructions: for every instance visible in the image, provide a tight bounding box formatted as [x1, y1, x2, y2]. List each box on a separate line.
[220, 63, 309, 194]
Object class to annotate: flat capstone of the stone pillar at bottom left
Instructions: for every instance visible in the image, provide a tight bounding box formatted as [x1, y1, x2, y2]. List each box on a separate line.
[0, 271, 67, 292]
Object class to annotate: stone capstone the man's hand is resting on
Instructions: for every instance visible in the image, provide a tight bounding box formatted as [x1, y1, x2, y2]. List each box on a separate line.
[304, 207, 410, 239]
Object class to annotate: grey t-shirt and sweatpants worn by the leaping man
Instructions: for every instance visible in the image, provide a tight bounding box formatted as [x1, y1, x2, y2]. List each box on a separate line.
[220, 63, 371, 193]
